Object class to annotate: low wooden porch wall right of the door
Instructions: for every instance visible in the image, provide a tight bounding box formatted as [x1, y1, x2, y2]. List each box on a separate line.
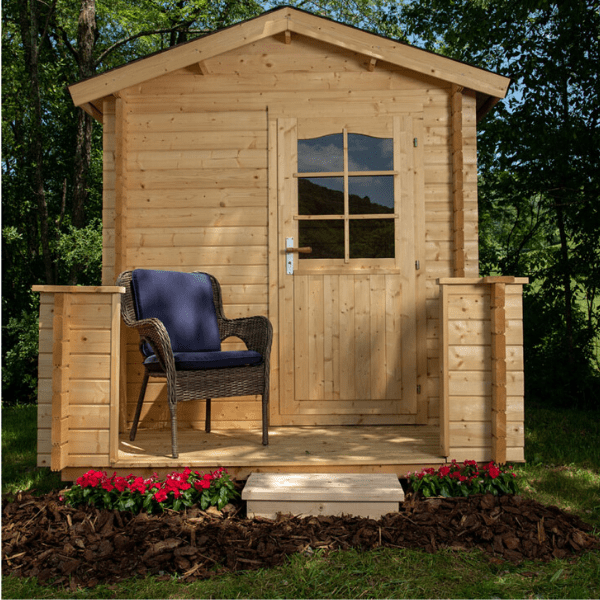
[440, 277, 527, 462]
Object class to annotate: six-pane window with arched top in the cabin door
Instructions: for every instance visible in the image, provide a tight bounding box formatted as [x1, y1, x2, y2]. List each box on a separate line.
[297, 133, 396, 262]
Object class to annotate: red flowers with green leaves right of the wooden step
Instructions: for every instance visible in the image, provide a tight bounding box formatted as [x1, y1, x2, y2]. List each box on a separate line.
[408, 460, 518, 498]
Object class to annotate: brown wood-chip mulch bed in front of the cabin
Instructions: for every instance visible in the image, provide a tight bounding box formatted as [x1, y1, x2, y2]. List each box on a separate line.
[2, 493, 600, 588]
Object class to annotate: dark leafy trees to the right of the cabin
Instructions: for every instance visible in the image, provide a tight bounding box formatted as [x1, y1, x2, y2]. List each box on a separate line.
[404, 0, 600, 404]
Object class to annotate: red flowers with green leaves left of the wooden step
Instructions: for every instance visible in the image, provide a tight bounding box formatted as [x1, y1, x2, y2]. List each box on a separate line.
[61, 467, 239, 514]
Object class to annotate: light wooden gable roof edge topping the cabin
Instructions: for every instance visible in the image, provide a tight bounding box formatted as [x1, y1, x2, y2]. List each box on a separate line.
[69, 6, 510, 120]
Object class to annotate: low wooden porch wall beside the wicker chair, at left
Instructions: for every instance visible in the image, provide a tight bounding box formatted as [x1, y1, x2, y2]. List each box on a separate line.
[33, 286, 121, 471]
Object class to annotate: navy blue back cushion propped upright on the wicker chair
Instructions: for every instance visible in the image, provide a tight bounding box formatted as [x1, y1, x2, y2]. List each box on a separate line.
[131, 269, 221, 356]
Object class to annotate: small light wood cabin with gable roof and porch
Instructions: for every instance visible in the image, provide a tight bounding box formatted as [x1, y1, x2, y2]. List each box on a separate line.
[34, 8, 527, 480]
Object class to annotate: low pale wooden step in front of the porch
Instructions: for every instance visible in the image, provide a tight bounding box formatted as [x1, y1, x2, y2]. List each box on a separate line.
[242, 473, 404, 519]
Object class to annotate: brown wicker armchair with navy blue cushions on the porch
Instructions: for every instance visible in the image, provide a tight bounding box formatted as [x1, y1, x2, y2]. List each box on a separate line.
[116, 269, 273, 458]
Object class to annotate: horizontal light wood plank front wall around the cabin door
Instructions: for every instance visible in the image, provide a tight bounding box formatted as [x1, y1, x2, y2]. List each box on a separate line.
[103, 35, 468, 428]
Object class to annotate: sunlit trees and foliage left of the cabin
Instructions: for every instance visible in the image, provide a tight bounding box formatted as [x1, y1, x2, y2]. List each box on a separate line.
[2, 0, 404, 402]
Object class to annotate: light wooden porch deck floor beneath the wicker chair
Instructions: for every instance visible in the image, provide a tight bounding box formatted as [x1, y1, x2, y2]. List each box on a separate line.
[105, 425, 444, 479]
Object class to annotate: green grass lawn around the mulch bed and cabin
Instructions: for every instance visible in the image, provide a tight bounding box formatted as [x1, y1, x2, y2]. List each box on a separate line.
[2, 398, 600, 598]
